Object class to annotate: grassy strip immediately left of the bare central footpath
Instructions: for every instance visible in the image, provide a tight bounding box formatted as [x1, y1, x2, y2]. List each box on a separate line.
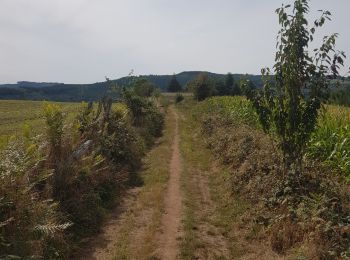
[114, 106, 175, 259]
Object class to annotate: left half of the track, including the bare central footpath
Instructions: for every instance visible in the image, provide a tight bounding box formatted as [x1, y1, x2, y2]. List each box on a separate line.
[74, 107, 182, 260]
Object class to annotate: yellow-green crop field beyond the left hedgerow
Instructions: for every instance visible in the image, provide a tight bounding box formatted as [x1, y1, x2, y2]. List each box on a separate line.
[0, 100, 80, 146]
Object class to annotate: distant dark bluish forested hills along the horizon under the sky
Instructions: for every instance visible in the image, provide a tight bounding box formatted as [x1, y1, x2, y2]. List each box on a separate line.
[0, 71, 261, 101]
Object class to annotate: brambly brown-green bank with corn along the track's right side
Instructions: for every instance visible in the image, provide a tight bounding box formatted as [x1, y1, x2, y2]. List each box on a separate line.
[192, 97, 350, 259]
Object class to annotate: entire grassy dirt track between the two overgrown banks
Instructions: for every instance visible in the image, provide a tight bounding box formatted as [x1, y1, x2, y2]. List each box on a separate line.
[74, 106, 283, 260]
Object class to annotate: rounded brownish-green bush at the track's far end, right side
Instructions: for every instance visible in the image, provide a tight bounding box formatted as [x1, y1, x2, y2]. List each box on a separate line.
[190, 73, 215, 101]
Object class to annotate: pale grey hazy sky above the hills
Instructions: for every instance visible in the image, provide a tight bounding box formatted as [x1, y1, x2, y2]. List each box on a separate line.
[0, 0, 350, 83]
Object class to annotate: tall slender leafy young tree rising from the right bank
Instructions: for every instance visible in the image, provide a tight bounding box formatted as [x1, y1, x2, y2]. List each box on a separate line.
[250, 0, 345, 176]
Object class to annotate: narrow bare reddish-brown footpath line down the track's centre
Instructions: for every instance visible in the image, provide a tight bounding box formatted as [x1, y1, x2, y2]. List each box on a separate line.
[159, 110, 182, 259]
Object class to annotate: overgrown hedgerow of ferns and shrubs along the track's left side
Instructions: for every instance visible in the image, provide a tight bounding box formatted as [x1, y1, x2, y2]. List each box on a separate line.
[0, 78, 164, 259]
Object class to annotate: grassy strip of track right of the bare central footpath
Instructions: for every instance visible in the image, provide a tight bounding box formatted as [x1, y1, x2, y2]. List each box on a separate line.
[178, 102, 258, 259]
